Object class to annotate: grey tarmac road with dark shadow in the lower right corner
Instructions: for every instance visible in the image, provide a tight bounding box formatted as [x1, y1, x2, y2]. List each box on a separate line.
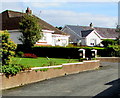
[3, 62, 119, 97]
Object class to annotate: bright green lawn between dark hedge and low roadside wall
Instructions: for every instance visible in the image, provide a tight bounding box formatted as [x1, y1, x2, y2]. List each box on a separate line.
[12, 57, 79, 67]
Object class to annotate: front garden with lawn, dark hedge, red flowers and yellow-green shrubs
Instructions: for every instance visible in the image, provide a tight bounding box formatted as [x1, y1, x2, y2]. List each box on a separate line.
[0, 31, 120, 75]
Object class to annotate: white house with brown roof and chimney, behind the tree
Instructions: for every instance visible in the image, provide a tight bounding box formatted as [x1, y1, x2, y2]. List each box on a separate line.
[0, 8, 70, 46]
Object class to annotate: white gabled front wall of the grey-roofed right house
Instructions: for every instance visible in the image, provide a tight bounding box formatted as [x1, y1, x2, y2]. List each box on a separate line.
[86, 31, 101, 46]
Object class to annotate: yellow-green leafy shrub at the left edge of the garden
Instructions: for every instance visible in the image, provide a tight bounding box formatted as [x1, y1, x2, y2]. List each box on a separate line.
[0, 31, 17, 65]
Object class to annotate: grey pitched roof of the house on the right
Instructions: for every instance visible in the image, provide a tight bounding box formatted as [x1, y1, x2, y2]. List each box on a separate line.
[67, 25, 120, 38]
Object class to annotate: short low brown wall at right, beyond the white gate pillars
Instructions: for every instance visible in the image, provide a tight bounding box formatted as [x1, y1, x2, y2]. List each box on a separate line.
[97, 57, 120, 62]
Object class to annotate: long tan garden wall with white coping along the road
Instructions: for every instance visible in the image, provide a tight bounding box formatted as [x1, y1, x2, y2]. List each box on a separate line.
[0, 60, 100, 90]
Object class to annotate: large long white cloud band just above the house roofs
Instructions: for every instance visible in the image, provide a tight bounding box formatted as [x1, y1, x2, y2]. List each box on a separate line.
[40, 10, 117, 27]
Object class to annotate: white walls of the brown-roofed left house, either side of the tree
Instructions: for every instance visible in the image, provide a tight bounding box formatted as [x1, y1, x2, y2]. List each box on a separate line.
[8, 30, 69, 46]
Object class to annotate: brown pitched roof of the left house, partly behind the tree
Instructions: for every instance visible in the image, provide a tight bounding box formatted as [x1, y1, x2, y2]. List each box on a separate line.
[0, 10, 67, 35]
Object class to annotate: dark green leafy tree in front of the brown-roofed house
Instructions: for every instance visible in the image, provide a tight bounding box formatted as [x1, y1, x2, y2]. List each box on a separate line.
[19, 14, 43, 48]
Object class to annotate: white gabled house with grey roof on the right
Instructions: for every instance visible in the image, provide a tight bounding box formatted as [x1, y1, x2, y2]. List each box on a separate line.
[62, 23, 119, 46]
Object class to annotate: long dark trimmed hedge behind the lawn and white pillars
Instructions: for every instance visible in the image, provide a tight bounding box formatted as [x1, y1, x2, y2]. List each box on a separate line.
[16, 45, 104, 59]
